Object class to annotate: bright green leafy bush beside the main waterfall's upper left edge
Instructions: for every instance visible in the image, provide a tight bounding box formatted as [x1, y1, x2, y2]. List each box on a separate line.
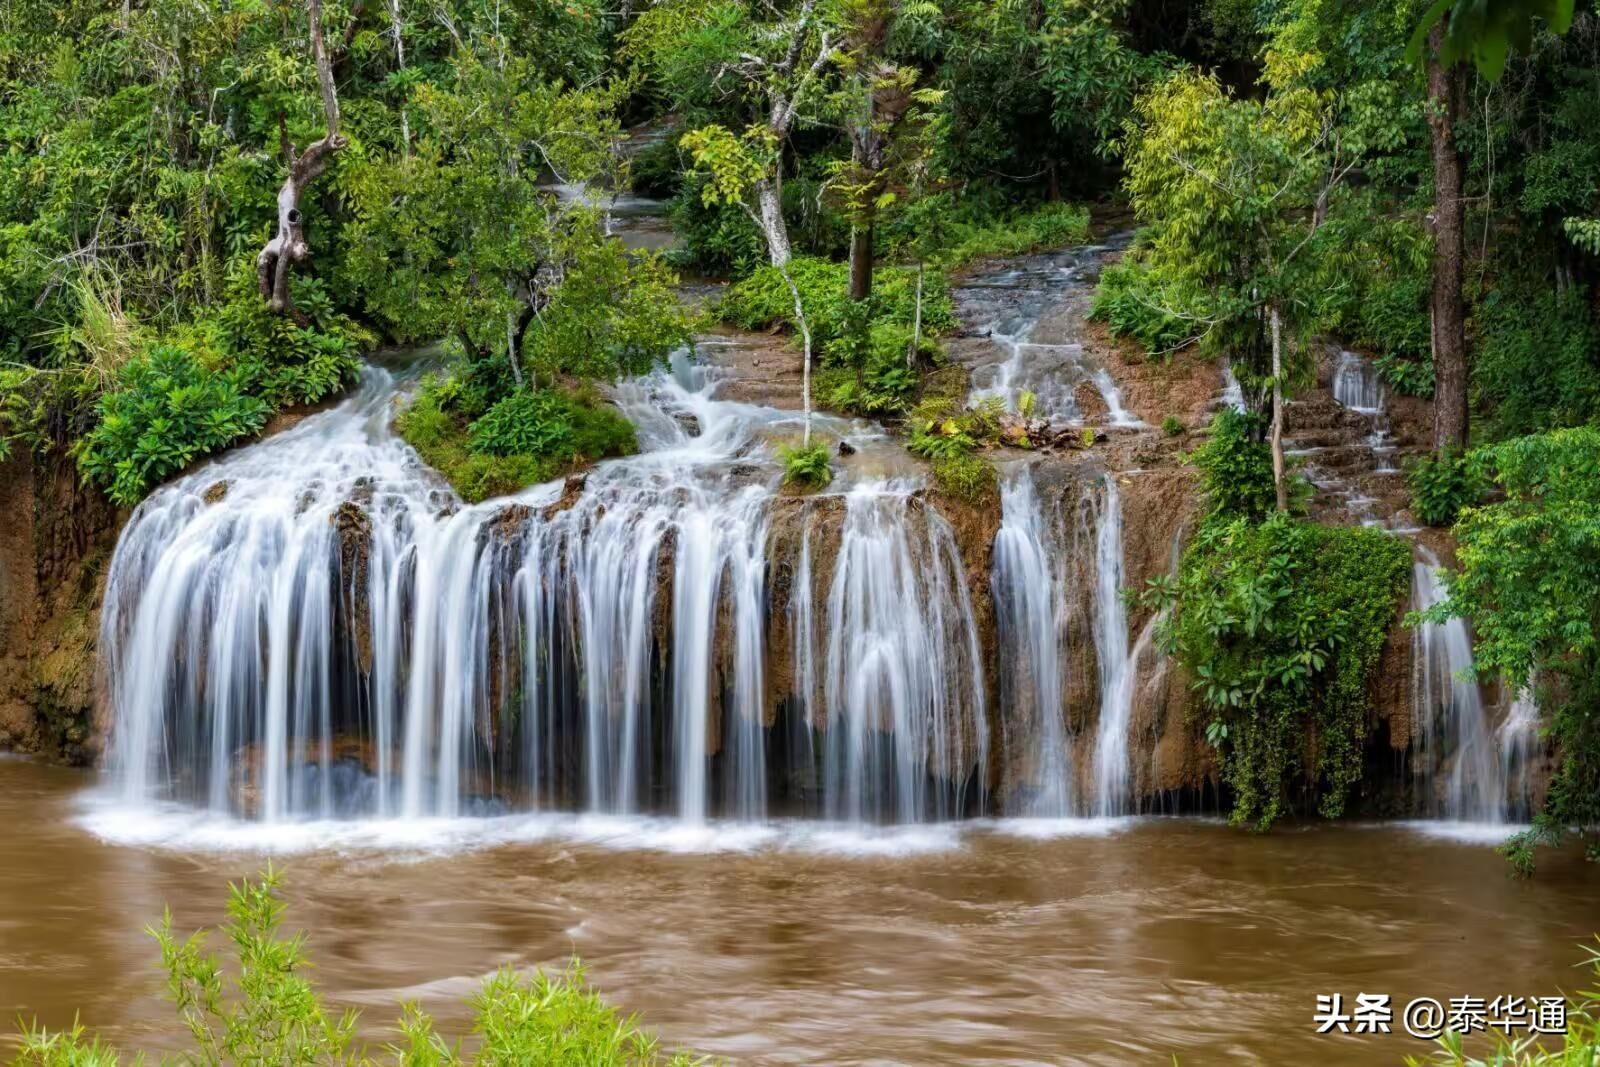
[78, 346, 270, 507]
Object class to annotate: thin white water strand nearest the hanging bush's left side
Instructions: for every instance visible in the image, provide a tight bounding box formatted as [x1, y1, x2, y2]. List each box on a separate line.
[1094, 475, 1136, 816]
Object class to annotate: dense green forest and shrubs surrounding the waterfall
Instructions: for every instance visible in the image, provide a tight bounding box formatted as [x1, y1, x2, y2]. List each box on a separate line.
[0, 0, 1600, 864]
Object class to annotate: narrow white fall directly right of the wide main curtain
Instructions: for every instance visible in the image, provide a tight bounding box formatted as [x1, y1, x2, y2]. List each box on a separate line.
[990, 467, 1074, 819]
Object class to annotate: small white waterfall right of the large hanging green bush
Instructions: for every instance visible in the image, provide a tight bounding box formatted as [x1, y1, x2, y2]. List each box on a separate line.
[1411, 556, 1507, 824]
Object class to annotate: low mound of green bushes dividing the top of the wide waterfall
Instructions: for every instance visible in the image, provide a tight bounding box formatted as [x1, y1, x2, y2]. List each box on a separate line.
[395, 371, 638, 502]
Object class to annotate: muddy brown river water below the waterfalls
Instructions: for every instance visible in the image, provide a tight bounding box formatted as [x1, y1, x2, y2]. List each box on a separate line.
[0, 760, 1600, 1064]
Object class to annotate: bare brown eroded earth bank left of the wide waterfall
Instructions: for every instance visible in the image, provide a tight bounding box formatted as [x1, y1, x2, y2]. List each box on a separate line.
[0, 450, 120, 763]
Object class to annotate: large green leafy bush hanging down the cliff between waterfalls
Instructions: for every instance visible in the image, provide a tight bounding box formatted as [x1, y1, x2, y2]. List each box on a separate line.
[1149, 512, 1411, 829]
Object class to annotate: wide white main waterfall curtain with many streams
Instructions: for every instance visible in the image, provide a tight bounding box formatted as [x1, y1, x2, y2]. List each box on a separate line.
[101, 357, 987, 824]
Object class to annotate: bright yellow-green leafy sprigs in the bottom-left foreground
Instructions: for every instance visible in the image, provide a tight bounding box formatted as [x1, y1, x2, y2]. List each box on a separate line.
[16, 867, 701, 1067]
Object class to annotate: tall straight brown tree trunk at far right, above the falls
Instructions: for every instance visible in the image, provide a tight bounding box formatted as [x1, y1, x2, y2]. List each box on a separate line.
[1427, 28, 1467, 453]
